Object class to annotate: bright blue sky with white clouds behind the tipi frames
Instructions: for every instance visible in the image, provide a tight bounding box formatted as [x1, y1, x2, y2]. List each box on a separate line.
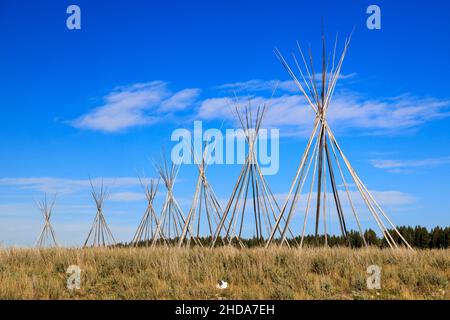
[0, 0, 450, 246]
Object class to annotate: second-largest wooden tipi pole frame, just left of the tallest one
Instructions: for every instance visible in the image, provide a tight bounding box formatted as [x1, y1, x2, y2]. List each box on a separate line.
[211, 102, 298, 247]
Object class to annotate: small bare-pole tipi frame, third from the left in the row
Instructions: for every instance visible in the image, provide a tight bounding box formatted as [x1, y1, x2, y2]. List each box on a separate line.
[132, 178, 159, 246]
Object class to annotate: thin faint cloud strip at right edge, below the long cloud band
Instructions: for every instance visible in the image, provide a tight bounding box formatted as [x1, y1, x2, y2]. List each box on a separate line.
[370, 157, 450, 173]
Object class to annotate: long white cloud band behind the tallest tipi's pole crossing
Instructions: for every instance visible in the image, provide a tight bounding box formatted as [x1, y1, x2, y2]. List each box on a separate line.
[197, 92, 450, 135]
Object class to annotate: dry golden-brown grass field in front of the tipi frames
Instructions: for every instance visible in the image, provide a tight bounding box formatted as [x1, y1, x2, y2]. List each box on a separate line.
[0, 248, 450, 300]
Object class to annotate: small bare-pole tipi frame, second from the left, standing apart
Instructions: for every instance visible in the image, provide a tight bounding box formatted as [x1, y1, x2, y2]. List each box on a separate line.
[83, 180, 116, 247]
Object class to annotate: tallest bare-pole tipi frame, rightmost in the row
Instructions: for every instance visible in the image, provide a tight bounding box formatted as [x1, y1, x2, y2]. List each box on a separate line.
[266, 36, 412, 249]
